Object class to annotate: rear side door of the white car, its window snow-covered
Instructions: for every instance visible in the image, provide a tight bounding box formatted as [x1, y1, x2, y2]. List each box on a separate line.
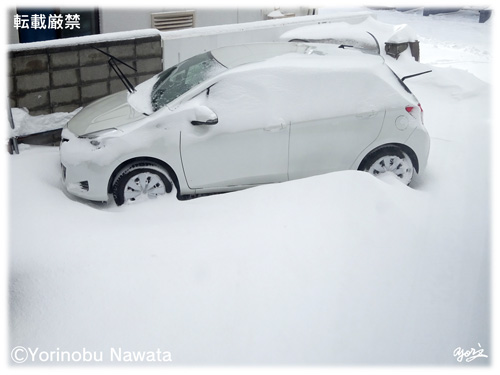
[289, 71, 387, 179]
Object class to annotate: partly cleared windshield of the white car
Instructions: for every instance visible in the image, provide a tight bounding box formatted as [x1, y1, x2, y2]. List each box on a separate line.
[151, 52, 227, 111]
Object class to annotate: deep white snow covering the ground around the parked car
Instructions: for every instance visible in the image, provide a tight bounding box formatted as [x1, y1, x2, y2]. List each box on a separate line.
[8, 7, 492, 367]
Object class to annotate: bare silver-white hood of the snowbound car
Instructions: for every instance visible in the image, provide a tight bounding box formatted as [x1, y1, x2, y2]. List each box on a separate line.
[68, 91, 145, 136]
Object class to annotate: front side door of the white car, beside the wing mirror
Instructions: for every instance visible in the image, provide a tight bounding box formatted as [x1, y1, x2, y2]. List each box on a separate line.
[180, 74, 290, 189]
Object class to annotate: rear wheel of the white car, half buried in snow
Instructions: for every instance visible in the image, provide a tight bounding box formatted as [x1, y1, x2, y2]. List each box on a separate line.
[361, 147, 415, 185]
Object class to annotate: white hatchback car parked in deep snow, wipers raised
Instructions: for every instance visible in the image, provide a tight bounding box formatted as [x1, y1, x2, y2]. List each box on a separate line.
[61, 43, 429, 205]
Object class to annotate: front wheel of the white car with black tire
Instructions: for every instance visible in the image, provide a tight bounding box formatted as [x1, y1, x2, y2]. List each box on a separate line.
[112, 163, 174, 206]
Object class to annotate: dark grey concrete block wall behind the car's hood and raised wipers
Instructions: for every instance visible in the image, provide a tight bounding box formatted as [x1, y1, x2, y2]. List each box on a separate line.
[8, 35, 163, 115]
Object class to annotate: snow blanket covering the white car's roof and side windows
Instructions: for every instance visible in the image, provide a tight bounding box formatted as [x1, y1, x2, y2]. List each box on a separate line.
[203, 42, 414, 122]
